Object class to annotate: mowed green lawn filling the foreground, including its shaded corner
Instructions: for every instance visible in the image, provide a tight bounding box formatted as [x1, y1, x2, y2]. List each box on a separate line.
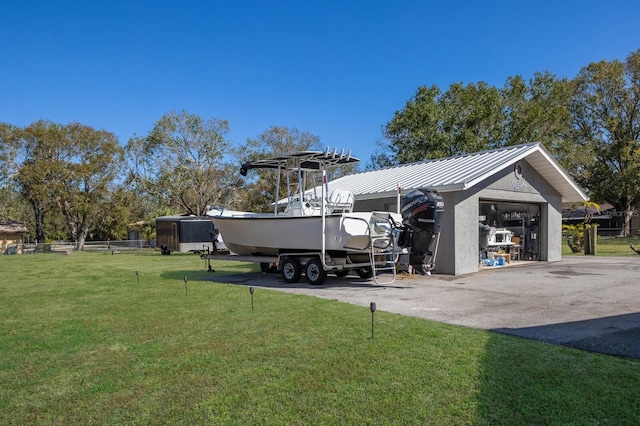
[0, 252, 640, 425]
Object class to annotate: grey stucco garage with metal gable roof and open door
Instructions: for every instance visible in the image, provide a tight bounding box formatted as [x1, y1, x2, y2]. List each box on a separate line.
[329, 143, 587, 275]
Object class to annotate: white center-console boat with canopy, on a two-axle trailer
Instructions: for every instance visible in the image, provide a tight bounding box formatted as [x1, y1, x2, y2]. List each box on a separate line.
[211, 149, 442, 284]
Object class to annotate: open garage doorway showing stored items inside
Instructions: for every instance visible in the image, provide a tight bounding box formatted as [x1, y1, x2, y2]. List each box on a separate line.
[478, 201, 541, 262]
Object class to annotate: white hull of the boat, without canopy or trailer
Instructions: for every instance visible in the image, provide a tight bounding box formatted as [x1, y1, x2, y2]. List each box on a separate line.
[211, 212, 398, 256]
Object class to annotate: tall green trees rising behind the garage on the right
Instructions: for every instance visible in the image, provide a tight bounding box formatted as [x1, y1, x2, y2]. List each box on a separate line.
[370, 50, 640, 236]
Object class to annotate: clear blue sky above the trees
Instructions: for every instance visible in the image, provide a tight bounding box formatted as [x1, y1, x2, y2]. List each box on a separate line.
[0, 0, 640, 163]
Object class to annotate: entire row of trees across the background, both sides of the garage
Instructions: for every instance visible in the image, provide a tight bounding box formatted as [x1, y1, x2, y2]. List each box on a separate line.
[0, 50, 640, 249]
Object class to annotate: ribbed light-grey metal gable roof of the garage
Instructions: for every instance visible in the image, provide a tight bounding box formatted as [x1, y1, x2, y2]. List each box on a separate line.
[329, 142, 587, 202]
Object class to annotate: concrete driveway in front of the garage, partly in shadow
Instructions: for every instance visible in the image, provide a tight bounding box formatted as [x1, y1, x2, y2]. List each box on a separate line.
[210, 256, 640, 359]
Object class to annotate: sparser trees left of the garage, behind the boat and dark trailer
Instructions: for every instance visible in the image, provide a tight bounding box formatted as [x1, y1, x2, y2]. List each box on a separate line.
[0, 111, 328, 250]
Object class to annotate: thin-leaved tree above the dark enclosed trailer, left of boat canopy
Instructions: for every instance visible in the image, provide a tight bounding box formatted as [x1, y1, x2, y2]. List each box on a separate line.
[127, 111, 231, 216]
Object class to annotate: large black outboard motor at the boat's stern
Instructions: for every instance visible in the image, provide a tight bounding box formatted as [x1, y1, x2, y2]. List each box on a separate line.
[400, 189, 444, 275]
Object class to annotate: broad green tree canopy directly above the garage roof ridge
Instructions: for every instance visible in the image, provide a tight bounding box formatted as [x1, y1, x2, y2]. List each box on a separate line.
[382, 73, 572, 165]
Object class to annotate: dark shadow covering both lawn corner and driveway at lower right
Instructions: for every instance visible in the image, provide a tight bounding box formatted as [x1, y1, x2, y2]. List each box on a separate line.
[477, 312, 640, 424]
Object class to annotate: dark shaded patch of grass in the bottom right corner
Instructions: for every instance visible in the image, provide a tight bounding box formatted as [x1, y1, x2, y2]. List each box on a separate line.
[474, 326, 640, 425]
